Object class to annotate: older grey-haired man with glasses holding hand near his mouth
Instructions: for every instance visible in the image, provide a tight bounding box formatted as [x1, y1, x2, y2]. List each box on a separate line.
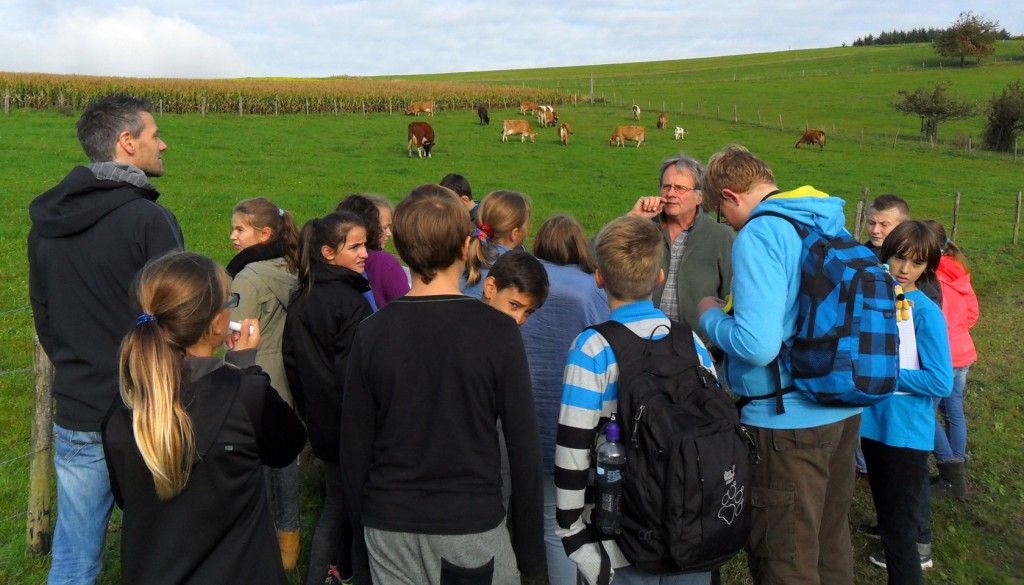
[629, 153, 735, 343]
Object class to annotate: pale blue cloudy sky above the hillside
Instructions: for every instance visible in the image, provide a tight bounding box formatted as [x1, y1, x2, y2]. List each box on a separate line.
[0, 0, 1024, 78]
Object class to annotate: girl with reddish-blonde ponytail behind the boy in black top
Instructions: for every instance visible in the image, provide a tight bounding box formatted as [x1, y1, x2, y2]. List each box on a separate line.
[460, 191, 529, 297]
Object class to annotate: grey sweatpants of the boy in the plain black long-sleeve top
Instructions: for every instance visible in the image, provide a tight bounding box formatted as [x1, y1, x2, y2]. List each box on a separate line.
[364, 520, 519, 585]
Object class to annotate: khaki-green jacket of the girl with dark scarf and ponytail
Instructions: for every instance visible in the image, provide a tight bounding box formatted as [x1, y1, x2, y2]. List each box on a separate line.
[231, 258, 298, 408]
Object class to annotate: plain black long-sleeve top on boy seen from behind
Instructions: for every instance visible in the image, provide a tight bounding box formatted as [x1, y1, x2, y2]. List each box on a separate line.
[341, 295, 545, 575]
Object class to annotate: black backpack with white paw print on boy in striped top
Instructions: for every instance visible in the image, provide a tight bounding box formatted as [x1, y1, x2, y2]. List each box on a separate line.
[592, 321, 757, 575]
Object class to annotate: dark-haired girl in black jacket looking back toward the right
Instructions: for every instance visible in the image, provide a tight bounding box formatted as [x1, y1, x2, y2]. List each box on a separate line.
[283, 212, 375, 585]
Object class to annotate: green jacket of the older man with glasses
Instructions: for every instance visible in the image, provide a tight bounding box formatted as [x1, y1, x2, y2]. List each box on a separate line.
[653, 207, 736, 343]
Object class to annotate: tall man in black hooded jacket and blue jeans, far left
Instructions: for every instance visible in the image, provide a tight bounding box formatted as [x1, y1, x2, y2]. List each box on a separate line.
[29, 95, 184, 584]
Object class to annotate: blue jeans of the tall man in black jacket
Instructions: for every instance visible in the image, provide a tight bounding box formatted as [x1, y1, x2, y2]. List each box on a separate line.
[48, 424, 114, 585]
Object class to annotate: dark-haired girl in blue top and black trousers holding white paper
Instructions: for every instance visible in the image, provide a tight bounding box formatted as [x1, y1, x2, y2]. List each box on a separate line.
[860, 221, 953, 585]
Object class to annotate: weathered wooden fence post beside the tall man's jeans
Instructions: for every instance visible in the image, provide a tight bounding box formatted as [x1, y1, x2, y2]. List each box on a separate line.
[26, 334, 53, 555]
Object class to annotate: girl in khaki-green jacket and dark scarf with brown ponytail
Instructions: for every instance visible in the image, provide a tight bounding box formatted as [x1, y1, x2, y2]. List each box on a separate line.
[227, 197, 299, 571]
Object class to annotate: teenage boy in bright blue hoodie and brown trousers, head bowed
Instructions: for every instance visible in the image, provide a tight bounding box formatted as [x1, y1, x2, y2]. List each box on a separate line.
[697, 145, 861, 585]
